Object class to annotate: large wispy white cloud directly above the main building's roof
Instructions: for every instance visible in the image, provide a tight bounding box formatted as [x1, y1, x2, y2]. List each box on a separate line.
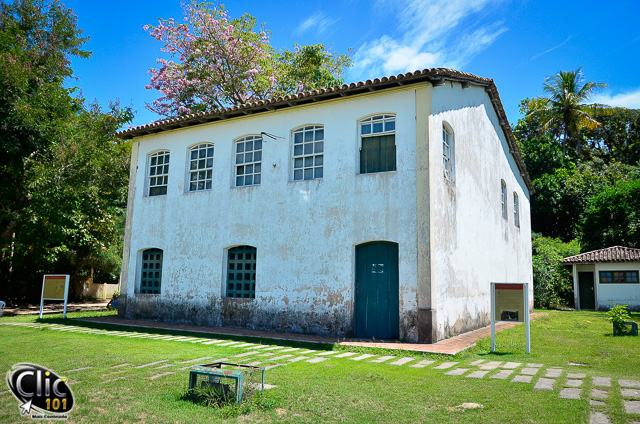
[350, 0, 507, 80]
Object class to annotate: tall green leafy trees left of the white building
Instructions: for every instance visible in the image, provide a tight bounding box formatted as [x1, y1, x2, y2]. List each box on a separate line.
[0, 0, 132, 301]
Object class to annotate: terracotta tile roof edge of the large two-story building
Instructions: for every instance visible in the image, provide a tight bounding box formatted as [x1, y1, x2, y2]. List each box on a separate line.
[116, 68, 534, 193]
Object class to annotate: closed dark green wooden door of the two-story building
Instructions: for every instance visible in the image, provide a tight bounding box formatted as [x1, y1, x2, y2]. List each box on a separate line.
[354, 241, 400, 339]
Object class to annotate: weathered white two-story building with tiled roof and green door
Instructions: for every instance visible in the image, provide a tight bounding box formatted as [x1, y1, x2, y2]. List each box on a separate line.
[119, 69, 533, 343]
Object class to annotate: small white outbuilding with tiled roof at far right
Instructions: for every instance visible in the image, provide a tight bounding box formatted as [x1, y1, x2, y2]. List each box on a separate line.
[562, 246, 640, 310]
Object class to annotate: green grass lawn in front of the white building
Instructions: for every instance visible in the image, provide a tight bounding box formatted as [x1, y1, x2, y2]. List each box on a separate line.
[0, 311, 640, 423]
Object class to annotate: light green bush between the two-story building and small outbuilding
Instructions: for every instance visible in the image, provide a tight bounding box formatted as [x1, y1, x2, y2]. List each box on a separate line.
[532, 233, 580, 308]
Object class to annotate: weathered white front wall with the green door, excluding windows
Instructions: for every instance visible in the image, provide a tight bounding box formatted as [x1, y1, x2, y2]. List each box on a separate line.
[123, 87, 424, 340]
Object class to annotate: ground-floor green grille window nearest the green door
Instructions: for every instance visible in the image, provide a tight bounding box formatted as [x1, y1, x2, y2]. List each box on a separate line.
[227, 246, 257, 299]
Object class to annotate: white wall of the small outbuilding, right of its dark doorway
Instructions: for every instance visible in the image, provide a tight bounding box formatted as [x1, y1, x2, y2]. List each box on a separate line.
[595, 262, 640, 311]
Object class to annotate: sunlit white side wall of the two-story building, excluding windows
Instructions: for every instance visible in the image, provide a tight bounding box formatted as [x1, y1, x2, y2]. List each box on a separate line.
[429, 81, 533, 338]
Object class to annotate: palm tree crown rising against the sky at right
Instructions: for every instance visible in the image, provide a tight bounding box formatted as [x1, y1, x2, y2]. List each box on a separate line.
[534, 68, 607, 156]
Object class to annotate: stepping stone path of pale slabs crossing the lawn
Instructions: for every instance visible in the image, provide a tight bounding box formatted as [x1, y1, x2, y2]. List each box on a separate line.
[10, 322, 640, 424]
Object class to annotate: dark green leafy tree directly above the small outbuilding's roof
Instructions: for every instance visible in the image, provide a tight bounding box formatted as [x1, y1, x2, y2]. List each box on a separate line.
[580, 178, 640, 250]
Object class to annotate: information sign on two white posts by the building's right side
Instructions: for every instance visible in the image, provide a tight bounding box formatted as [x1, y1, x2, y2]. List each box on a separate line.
[491, 283, 531, 353]
